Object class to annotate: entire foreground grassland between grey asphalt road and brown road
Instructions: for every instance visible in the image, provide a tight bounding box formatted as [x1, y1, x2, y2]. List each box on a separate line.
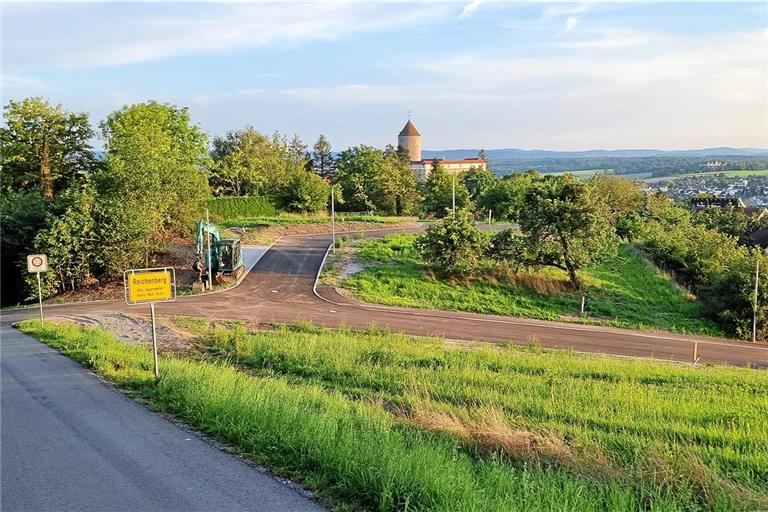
[21, 318, 768, 511]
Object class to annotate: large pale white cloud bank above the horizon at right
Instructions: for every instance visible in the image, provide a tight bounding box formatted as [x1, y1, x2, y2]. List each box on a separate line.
[282, 30, 768, 149]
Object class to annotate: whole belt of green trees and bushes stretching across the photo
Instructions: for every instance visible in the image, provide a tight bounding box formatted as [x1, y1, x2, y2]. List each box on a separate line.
[0, 98, 768, 340]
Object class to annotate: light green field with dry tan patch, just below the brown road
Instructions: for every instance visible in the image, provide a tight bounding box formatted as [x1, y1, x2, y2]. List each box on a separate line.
[182, 325, 768, 508]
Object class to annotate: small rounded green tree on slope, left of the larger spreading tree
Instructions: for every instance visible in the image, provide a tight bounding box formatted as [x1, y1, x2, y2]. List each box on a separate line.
[415, 210, 486, 275]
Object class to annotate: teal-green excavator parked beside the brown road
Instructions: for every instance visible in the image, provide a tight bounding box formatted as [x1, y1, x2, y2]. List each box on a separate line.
[193, 220, 243, 289]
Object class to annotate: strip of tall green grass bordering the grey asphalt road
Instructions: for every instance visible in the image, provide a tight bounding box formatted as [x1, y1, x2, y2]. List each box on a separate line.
[16, 321, 704, 511]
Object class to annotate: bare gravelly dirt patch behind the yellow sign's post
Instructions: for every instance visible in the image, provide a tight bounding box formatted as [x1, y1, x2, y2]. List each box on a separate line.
[49, 313, 195, 352]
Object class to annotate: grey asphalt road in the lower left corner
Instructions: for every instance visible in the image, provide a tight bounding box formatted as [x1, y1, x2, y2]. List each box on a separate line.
[0, 324, 324, 512]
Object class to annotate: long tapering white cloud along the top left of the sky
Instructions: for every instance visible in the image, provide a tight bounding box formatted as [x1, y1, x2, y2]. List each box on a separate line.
[3, 2, 457, 69]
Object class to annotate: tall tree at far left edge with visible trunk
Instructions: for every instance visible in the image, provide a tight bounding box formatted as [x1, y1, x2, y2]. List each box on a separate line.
[0, 98, 94, 198]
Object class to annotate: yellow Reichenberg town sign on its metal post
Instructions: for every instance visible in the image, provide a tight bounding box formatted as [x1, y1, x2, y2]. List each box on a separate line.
[123, 267, 176, 379]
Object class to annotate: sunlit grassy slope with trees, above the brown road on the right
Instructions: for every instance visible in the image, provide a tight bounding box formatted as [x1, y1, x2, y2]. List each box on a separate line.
[341, 235, 723, 336]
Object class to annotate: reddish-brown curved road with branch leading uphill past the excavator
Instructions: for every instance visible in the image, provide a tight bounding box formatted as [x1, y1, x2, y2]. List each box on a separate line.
[4, 228, 768, 366]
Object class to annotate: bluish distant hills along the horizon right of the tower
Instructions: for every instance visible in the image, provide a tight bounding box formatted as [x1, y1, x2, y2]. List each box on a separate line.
[422, 147, 768, 160]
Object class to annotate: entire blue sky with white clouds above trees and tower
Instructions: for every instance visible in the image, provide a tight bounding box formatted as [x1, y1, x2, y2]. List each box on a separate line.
[0, 0, 768, 150]
